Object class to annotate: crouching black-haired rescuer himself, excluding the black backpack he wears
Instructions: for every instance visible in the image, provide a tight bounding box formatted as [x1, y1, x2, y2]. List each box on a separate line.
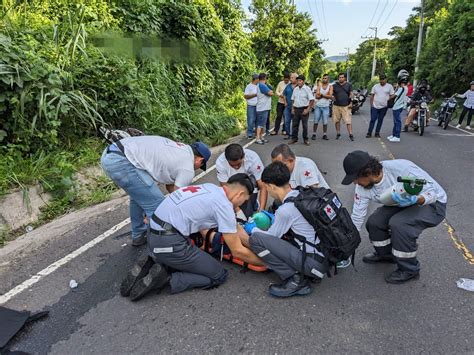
[249, 162, 328, 297]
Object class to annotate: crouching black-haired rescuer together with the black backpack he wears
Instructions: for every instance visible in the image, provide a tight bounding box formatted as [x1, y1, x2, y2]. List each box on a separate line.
[246, 162, 360, 297]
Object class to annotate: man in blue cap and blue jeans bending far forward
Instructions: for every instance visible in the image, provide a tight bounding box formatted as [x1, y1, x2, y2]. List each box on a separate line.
[101, 136, 211, 246]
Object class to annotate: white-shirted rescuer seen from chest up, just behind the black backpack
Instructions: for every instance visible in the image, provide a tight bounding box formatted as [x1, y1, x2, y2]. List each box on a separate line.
[271, 144, 329, 189]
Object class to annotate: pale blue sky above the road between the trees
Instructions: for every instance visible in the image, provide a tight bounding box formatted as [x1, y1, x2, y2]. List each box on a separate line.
[241, 0, 420, 56]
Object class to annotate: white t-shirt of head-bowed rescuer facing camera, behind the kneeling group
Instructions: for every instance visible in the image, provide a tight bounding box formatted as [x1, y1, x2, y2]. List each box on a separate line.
[216, 149, 264, 182]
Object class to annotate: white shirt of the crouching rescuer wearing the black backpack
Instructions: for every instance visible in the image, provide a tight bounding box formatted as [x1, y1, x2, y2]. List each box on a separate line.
[252, 191, 323, 256]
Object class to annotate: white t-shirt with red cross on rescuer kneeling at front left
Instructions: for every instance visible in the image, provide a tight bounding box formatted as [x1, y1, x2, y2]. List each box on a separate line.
[150, 184, 237, 236]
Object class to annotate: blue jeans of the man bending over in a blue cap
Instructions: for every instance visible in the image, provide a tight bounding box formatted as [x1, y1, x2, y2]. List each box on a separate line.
[100, 149, 165, 239]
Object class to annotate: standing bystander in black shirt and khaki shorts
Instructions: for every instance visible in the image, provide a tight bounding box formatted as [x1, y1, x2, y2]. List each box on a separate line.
[332, 73, 354, 141]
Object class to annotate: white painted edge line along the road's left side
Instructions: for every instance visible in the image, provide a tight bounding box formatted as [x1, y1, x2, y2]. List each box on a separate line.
[0, 139, 255, 305]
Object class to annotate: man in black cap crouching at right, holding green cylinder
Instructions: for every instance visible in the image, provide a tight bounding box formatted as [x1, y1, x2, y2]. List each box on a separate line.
[342, 150, 447, 284]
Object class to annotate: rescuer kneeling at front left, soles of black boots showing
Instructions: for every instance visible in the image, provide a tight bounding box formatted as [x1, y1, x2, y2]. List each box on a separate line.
[120, 174, 263, 301]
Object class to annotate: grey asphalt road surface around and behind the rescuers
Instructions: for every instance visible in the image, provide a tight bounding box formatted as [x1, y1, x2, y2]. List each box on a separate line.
[0, 107, 474, 354]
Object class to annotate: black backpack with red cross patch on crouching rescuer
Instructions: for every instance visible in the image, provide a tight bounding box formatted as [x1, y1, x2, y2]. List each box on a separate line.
[285, 186, 360, 265]
